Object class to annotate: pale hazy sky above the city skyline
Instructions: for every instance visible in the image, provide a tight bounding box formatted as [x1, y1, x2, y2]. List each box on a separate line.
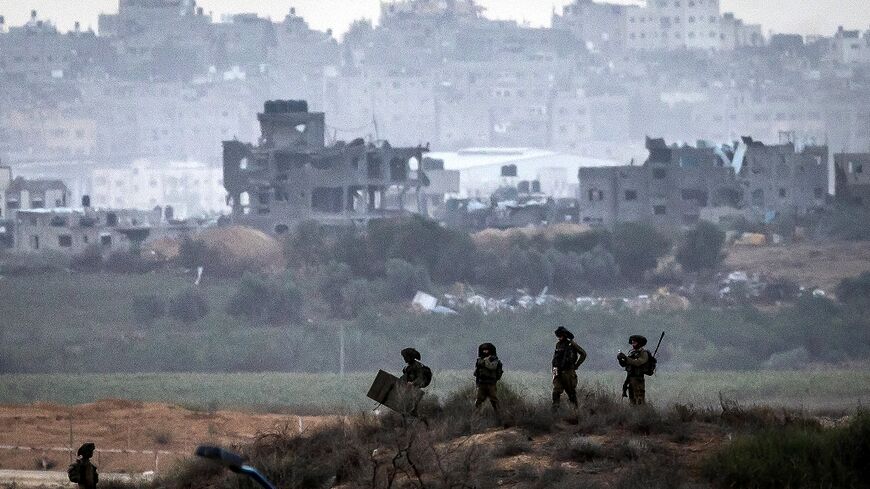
[0, 0, 870, 35]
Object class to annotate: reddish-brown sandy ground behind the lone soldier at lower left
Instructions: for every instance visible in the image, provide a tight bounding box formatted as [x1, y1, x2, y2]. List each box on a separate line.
[0, 400, 334, 473]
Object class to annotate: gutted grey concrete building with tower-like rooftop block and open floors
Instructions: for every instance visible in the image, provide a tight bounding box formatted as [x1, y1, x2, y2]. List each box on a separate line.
[223, 100, 428, 234]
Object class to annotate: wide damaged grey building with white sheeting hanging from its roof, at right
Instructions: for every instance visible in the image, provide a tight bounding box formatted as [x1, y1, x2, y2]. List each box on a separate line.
[578, 138, 828, 228]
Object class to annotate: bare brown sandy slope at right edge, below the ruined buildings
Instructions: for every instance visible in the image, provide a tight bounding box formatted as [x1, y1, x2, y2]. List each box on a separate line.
[725, 242, 870, 291]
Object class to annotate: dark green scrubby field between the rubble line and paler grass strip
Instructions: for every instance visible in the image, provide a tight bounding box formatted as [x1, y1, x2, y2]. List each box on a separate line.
[0, 271, 870, 373]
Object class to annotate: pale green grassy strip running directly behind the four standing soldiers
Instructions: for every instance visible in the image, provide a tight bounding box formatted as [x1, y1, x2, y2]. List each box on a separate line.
[0, 370, 870, 412]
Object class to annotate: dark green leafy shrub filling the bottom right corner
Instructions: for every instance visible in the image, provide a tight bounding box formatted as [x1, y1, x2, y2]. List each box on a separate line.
[702, 412, 870, 489]
